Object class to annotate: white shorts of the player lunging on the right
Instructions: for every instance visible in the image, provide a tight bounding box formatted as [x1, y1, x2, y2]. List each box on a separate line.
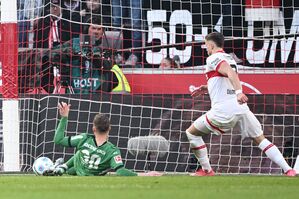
[193, 111, 263, 139]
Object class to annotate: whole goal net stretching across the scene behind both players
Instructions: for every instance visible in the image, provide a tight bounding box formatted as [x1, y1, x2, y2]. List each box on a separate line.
[0, 0, 299, 174]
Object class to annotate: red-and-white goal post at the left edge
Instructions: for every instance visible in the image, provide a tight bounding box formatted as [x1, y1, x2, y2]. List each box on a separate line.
[0, 0, 20, 172]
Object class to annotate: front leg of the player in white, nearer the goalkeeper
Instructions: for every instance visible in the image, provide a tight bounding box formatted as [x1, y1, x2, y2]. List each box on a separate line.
[186, 115, 214, 176]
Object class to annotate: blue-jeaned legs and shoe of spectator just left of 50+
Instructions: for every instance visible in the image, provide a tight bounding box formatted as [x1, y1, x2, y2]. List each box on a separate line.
[111, 0, 143, 67]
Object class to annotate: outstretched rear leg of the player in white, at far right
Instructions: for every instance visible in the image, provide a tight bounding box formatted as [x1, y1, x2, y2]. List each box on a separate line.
[243, 111, 296, 176]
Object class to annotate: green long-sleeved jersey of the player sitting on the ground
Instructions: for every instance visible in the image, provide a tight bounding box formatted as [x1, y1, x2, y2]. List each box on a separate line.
[54, 117, 123, 176]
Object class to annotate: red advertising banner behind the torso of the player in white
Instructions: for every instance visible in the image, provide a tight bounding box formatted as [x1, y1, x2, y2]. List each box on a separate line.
[126, 74, 299, 94]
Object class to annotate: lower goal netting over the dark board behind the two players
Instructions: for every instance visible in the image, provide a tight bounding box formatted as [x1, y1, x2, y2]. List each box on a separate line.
[8, 95, 299, 174]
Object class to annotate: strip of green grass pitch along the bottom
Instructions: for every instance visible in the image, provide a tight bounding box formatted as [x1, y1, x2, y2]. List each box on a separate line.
[0, 175, 299, 199]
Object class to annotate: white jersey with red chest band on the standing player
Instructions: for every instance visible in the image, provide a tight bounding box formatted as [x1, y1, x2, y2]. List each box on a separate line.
[205, 51, 249, 121]
